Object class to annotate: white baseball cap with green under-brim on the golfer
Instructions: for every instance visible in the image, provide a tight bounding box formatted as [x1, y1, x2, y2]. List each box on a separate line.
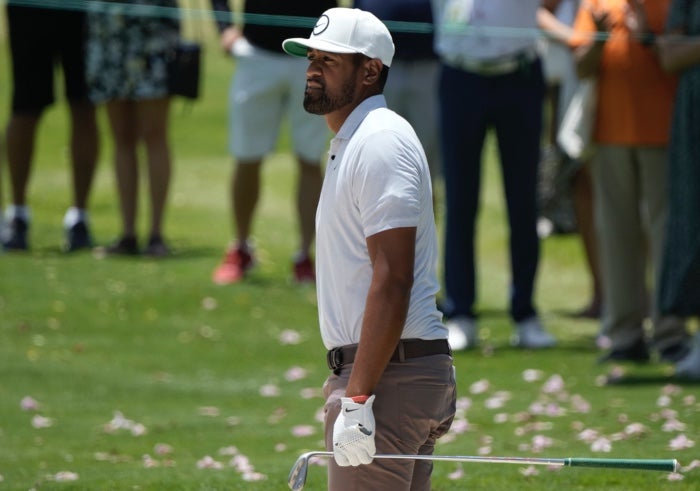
[282, 7, 394, 66]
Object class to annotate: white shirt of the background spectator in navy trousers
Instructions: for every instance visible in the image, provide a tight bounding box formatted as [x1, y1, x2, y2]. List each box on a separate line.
[431, 0, 541, 60]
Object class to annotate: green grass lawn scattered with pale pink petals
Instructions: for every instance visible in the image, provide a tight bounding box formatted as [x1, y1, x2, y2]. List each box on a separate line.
[0, 4, 700, 491]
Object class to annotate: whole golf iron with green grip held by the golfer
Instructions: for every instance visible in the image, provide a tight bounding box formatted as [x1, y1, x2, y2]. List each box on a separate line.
[287, 451, 678, 491]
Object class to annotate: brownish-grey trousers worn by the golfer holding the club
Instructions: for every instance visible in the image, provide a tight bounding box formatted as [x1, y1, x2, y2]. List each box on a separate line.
[323, 355, 456, 491]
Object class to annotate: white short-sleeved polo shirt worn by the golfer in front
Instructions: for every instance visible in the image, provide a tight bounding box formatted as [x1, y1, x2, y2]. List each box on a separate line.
[316, 95, 447, 349]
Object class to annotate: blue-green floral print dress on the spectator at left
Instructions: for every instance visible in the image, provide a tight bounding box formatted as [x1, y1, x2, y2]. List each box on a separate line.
[86, 0, 180, 103]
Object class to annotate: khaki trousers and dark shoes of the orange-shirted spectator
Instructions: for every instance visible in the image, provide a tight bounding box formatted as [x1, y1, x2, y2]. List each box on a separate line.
[591, 145, 686, 349]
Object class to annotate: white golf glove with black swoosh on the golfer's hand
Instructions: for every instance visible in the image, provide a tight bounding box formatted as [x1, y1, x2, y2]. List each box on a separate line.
[333, 396, 377, 467]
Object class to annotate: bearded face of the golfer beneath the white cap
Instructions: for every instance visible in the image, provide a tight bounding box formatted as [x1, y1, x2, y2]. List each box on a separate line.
[304, 49, 360, 115]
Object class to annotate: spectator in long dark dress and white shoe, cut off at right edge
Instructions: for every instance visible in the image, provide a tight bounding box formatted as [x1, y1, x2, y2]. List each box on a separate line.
[658, 0, 700, 380]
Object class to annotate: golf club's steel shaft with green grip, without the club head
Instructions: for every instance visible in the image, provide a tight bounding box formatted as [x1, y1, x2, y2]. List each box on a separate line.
[302, 452, 678, 472]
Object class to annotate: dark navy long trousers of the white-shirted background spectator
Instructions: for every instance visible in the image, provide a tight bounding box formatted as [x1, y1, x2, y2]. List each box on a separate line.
[440, 61, 544, 322]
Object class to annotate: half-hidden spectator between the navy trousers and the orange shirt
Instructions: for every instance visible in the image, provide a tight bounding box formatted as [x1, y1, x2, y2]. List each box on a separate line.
[537, 0, 603, 319]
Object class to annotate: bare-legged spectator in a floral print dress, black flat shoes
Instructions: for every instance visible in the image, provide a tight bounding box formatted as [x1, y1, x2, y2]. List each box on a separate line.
[87, 0, 180, 257]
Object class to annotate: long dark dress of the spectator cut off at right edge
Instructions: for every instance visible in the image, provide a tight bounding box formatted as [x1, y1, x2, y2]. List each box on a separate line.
[659, 0, 700, 316]
